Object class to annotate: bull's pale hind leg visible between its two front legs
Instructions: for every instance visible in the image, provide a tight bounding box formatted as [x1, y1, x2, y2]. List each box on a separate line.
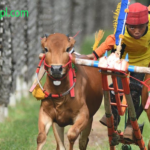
[53, 123, 65, 150]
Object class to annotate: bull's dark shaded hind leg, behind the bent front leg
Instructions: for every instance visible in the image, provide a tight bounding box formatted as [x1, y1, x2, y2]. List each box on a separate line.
[79, 118, 93, 150]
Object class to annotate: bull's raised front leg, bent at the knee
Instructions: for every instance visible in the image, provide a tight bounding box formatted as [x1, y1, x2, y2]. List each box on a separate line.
[67, 112, 88, 150]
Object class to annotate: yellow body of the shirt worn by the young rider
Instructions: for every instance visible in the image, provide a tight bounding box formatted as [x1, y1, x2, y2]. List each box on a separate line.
[122, 15, 150, 66]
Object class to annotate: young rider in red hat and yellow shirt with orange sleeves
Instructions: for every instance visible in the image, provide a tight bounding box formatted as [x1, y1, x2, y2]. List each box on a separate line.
[87, 3, 150, 141]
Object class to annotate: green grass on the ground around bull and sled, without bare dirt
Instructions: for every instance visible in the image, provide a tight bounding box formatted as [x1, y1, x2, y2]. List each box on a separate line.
[0, 97, 150, 150]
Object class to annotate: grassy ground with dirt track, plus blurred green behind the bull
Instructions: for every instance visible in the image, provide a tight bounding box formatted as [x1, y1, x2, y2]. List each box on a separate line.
[0, 33, 150, 150]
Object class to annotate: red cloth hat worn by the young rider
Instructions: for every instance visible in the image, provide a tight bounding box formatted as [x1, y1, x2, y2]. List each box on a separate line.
[126, 3, 148, 25]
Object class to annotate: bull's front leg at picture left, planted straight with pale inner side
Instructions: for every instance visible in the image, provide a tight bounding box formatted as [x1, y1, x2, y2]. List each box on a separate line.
[37, 107, 52, 150]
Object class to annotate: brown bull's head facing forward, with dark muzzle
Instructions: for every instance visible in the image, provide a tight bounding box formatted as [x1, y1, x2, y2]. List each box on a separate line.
[41, 33, 75, 78]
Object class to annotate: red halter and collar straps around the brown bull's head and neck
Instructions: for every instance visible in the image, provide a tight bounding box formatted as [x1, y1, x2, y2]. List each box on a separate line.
[36, 55, 76, 98]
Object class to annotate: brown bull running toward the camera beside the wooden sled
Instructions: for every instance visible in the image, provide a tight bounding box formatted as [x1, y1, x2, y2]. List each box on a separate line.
[37, 33, 103, 150]
